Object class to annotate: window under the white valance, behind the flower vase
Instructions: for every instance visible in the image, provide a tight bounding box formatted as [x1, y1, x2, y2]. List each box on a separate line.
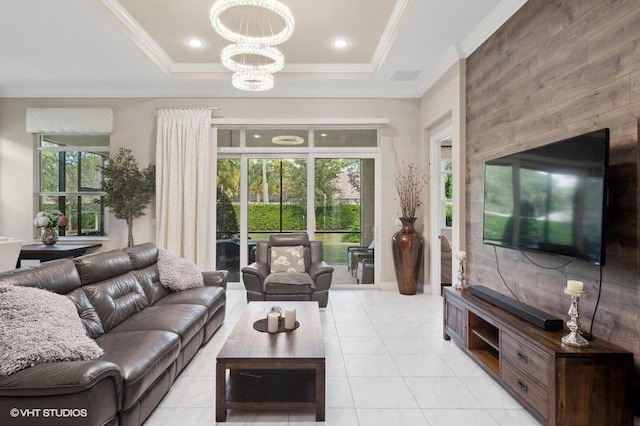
[36, 135, 109, 236]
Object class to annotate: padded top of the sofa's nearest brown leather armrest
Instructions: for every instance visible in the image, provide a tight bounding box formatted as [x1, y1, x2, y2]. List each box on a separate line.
[0, 360, 122, 401]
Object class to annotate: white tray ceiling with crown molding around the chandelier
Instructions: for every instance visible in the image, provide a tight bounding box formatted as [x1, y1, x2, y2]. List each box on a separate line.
[0, 0, 526, 98]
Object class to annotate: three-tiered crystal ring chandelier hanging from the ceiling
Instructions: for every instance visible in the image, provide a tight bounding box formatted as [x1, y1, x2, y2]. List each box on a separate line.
[210, 0, 294, 91]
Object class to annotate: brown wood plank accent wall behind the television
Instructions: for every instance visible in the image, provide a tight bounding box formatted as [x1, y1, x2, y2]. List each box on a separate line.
[466, 0, 640, 376]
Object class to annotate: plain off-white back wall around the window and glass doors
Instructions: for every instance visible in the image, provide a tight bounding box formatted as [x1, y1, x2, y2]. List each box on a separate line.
[0, 98, 421, 282]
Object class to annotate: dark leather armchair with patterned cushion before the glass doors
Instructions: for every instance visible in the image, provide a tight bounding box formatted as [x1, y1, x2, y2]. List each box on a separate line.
[242, 233, 333, 308]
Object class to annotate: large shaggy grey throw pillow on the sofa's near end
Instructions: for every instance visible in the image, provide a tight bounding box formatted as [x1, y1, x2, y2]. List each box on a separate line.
[0, 285, 104, 376]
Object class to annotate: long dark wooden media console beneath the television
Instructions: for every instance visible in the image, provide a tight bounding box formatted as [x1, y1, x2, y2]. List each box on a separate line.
[443, 288, 633, 426]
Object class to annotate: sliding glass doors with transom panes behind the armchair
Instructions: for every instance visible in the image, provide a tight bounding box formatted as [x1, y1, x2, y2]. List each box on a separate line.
[216, 129, 379, 284]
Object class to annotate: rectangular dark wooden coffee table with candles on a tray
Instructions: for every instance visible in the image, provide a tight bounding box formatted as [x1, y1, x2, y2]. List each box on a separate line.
[216, 301, 325, 422]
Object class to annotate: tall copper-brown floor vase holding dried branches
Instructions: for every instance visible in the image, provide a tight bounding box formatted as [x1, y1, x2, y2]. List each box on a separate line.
[391, 217, 424, 294]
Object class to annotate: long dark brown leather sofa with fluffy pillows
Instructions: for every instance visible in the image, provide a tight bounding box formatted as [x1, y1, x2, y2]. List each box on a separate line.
[0, 244, 227, 426]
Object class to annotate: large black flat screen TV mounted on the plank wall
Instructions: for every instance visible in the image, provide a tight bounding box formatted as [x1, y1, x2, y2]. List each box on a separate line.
[483, 129, 609, 265]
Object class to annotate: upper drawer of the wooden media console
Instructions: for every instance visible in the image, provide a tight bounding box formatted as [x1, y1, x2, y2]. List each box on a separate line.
[500, 332, 549, 388]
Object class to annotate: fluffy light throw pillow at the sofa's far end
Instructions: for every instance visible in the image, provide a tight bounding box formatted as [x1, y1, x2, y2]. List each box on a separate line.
[158, 249, 204, 291]
